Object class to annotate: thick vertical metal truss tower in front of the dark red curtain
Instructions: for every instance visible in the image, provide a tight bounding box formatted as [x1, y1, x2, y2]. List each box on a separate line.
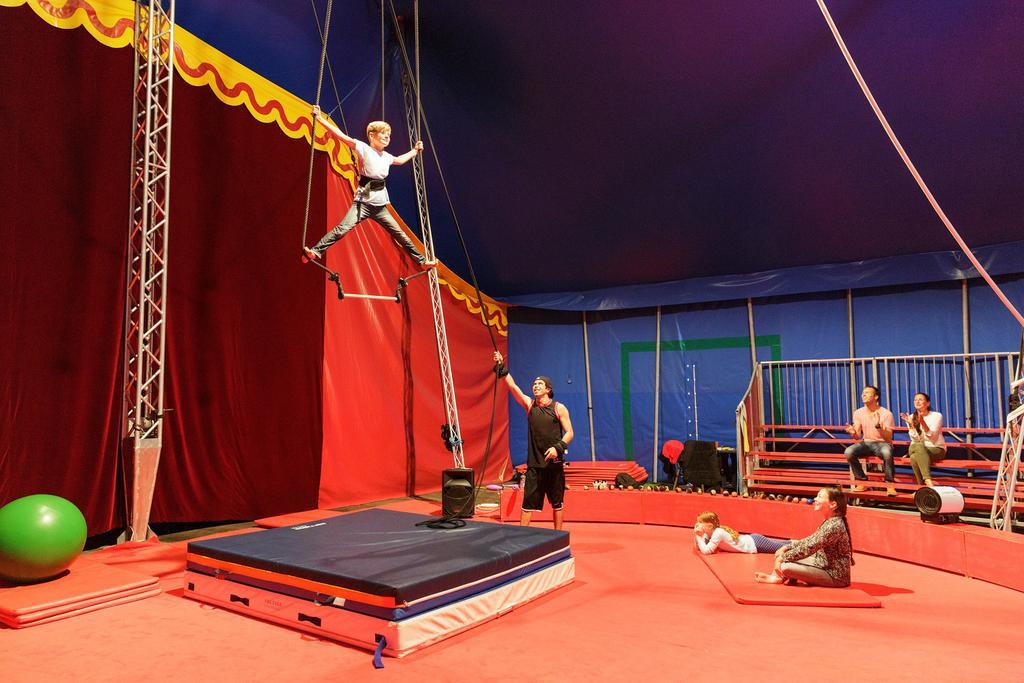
[121, 0, 174, 541]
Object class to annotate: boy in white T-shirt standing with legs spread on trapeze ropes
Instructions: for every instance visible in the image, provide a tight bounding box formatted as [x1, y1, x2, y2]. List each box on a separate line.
[302, 106, 437, 268]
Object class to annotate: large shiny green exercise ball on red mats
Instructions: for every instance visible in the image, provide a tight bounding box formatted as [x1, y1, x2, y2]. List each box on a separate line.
[0, 494, 87, 584]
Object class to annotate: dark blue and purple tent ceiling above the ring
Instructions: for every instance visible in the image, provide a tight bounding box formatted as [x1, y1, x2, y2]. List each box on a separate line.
[177, 0, 1024, 296]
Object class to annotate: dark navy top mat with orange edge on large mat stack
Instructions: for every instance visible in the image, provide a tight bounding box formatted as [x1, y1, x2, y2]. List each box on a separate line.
[188, 509, 568, 608]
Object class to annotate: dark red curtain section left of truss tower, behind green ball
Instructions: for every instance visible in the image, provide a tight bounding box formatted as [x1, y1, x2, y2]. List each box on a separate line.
[0, 6, 132, 533]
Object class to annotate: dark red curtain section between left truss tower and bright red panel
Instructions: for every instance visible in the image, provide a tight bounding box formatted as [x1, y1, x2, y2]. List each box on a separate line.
[153, 76, 326, 521]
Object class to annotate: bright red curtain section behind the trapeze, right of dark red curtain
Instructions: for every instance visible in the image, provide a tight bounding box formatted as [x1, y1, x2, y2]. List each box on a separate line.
[317, 175, 509, 508]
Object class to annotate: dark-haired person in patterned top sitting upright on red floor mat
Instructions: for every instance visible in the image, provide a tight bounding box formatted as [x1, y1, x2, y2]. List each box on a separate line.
[754, 486, 853, 588]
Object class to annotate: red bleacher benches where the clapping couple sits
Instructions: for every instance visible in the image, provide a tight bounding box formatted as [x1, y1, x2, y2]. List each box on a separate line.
[744, 424, 1024, 511]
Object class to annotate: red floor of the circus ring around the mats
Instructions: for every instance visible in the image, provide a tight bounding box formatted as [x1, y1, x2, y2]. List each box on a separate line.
[0, 504, 1024, 683]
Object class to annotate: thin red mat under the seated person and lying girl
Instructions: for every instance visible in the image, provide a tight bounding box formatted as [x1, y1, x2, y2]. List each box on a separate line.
[697, 553, 882, 607]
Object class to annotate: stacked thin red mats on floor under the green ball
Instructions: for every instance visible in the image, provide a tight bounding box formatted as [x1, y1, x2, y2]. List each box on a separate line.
[0, 557, 161, 629]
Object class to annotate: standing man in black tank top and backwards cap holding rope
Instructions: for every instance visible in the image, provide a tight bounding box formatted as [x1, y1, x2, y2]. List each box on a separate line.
[495, 351, 572, 529]
